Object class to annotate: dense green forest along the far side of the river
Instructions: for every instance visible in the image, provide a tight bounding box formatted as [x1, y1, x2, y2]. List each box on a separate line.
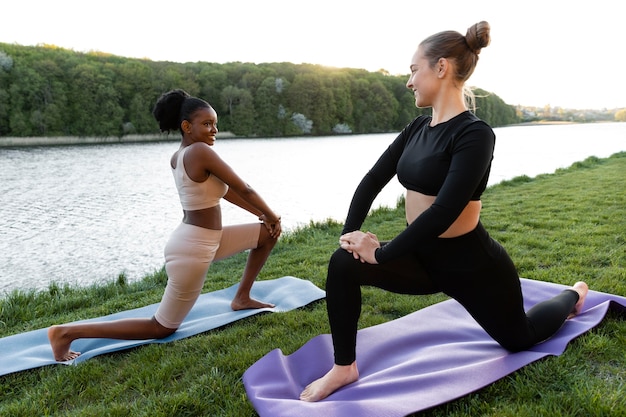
[0, 43, 519, 137]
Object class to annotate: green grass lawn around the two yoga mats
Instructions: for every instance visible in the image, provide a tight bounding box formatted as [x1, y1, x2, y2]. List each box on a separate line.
[0, 152, 626, 417]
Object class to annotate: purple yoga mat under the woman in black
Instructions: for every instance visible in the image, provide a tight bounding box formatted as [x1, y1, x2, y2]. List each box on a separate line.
[243, 279, 626, 417]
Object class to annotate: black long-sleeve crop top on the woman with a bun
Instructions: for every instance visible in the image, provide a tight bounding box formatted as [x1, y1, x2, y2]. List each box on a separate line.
[342, 111, 495, 263]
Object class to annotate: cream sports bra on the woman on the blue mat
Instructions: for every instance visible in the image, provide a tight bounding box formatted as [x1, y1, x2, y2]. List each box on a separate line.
[172, 147, 228, 210]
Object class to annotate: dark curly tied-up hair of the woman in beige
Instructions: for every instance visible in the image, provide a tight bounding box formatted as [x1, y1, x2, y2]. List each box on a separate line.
[152, 89, 211, 134]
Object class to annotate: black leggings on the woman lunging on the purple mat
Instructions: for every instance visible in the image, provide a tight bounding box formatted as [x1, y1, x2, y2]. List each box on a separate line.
[326, 224, 578, 365]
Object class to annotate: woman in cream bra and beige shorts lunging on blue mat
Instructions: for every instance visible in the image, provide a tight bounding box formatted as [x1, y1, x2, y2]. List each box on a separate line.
[48, 90, 282, 361]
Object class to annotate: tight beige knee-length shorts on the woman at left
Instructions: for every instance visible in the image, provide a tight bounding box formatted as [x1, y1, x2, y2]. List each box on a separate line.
[154, 223, 261, 329]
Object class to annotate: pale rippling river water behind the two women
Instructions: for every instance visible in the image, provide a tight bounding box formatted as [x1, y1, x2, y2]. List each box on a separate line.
[0, 123, 626, 297]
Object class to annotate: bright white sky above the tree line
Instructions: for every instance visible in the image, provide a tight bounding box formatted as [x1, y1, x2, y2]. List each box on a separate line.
[0, 0, 626, 109]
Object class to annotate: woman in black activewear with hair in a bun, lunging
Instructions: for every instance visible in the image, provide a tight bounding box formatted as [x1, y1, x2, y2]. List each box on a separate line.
[300, 22, 588, 401]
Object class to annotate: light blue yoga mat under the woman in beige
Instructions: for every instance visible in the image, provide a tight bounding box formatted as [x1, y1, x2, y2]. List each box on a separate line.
[0, 276, 326, 375]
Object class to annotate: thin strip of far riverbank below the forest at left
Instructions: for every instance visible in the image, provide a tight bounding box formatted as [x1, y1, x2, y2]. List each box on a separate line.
[0, 132, 237, 148]
